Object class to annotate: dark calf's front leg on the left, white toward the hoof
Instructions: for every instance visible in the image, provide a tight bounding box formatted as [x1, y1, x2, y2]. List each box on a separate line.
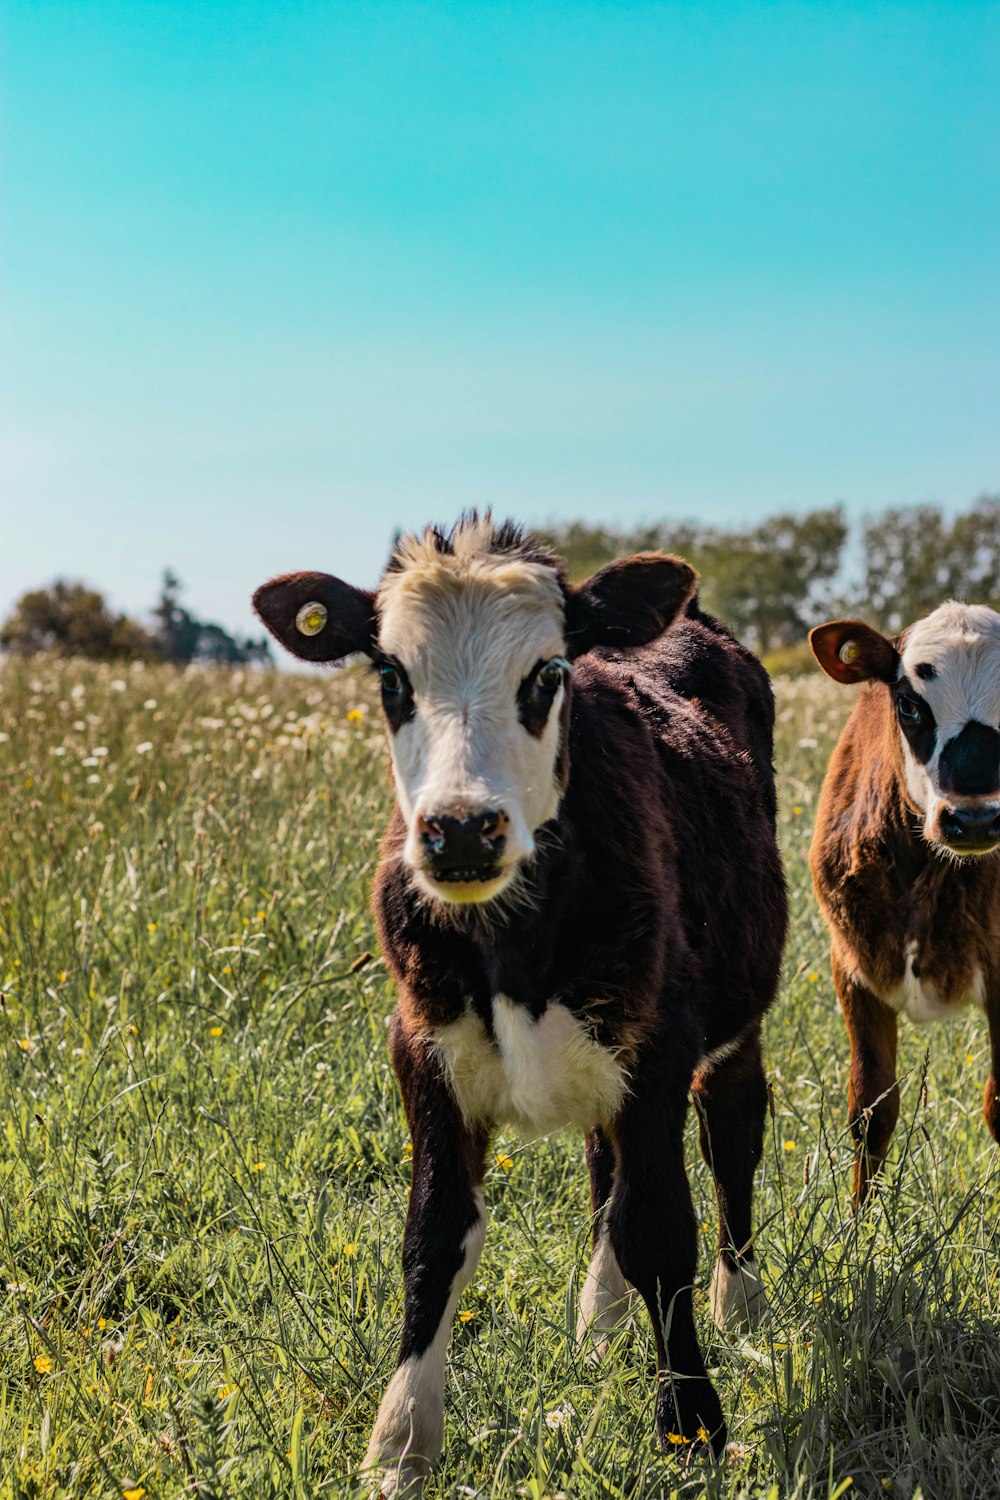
[364, 1017, 487, 1496]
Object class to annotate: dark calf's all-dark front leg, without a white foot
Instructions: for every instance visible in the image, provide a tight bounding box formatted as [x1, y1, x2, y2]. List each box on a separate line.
[607, 1049, 726, 1454]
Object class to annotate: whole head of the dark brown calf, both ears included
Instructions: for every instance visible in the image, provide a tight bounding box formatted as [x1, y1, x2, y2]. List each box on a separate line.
[253, 515, 696, 905]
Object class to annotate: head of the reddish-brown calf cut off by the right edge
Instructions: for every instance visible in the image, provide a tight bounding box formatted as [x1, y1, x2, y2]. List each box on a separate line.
[810, 602, 1000, 857]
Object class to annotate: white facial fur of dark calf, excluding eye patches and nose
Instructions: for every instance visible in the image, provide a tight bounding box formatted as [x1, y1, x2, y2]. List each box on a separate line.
[378, 525, 565, 900]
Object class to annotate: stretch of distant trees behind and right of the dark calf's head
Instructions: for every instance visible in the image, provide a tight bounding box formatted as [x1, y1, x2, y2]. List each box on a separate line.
[543, 495, 1000, 656]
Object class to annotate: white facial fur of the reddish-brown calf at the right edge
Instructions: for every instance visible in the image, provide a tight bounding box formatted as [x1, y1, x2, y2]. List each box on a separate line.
[900, 600, 1000, 840]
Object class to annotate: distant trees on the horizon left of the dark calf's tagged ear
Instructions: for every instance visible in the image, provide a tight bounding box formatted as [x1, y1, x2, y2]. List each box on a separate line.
[0, 569, 271, 666]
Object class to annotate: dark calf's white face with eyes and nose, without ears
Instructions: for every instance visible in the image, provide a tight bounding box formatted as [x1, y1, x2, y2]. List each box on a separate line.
[375, 536, 570, 903]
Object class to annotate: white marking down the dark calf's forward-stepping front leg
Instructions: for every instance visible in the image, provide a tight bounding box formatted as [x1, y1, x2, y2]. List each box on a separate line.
[363, 1188, 486, 1500]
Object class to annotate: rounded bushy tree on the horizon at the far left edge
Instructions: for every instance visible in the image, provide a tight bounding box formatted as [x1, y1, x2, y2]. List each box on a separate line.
[0, 579, 157, 662]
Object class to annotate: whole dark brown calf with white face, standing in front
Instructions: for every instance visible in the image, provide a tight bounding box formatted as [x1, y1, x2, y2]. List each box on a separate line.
[255, 516, 786, 1493]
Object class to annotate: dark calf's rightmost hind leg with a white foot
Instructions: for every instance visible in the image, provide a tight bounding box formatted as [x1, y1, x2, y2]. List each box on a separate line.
[693, 1025, 768, 1332]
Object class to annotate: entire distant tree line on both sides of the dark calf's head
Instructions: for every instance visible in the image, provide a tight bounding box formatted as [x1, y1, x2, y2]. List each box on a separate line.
[0, 495, 1000, 666]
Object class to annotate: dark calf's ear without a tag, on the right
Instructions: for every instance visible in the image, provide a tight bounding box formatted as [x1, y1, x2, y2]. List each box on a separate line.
[567, 552, 697, 657]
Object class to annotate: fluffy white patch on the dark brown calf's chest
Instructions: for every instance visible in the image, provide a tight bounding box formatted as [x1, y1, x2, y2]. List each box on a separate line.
[433, 995, 627, 1136]
